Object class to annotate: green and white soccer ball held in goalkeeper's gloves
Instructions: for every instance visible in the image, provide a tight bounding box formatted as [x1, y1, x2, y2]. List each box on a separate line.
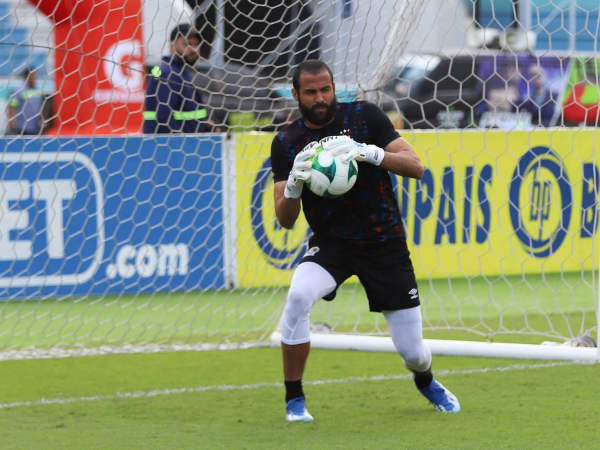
[307, 147, 358, 197]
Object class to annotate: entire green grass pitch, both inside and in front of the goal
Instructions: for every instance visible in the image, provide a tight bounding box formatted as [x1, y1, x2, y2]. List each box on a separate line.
[0, 273, 600, 450]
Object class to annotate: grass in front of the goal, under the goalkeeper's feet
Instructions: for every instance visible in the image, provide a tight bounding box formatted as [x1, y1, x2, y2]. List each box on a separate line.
[0, 348, 600, 450]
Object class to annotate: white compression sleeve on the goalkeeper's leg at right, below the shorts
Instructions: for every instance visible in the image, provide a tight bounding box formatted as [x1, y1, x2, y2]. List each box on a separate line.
[383, 306, 431, 372]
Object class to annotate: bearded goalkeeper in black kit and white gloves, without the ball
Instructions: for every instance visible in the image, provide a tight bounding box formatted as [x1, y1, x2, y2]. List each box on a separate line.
[271, 60, 460, 422]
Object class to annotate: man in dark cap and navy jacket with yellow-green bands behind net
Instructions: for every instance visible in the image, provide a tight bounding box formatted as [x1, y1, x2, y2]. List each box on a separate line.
[144, 24, 208, 134]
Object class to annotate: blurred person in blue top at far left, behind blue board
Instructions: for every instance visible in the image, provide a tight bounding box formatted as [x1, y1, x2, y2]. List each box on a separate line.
[7, 68, 45, 135]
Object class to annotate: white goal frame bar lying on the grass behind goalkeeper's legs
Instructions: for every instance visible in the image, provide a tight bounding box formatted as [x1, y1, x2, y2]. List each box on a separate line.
[271, 332, 598, 362]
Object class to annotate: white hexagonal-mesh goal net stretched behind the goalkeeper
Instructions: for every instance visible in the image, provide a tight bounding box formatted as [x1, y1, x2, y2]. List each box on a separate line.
[0, 0, 600, 359]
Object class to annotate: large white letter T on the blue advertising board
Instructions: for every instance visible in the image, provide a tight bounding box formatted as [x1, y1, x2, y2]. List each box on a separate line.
[33, 180, 76, 258]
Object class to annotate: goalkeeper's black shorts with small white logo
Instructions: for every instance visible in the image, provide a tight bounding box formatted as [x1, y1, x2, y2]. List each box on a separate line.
[300, 236, 420, 312]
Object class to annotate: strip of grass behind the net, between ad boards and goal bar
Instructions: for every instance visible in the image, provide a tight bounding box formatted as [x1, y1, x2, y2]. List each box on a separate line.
[0, 272, 596, 349]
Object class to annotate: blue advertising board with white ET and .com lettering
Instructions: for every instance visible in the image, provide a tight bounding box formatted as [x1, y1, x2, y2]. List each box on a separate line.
[0, 136, 225, 299]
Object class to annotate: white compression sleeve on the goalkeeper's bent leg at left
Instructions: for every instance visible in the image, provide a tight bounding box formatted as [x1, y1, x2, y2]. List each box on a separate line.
[281, 262, 336, 345]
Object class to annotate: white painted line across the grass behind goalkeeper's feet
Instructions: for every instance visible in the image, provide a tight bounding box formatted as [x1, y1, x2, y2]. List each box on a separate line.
[0, 362, 593, 409]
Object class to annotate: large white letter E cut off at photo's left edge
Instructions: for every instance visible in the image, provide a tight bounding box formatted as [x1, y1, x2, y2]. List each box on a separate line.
[0, 180, 33, 261]
